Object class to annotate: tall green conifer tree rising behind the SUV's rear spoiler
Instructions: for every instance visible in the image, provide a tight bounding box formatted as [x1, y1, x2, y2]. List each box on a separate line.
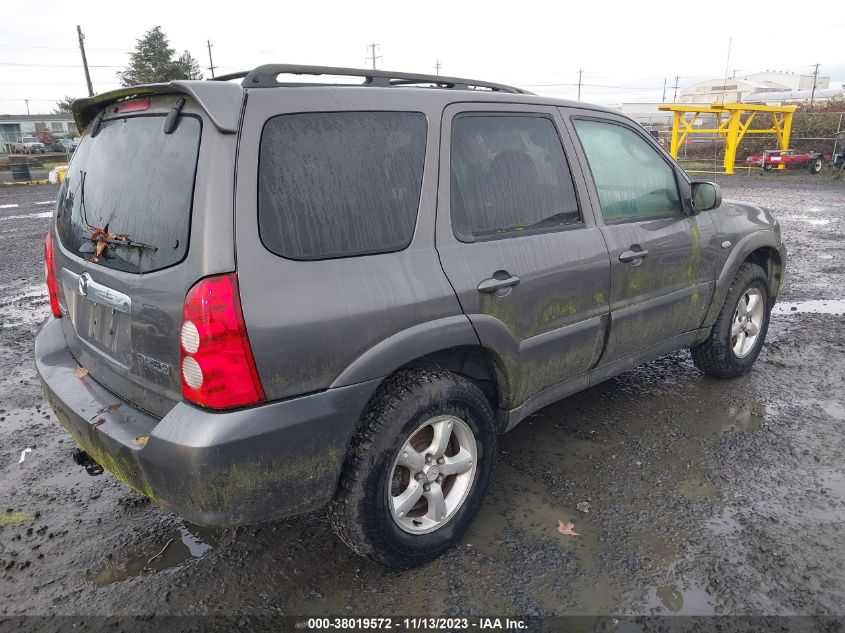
[117, 26, 202, 86]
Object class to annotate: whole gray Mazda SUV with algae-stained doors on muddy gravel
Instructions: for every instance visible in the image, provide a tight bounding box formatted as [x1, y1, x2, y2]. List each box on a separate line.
[35, 65, 786, 567]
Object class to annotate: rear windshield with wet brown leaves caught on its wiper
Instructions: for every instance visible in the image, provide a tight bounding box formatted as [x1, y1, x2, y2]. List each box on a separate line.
[56, 116, 202, 273]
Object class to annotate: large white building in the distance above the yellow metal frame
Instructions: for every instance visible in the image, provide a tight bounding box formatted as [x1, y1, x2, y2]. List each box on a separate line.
[678, 70, 830, 103]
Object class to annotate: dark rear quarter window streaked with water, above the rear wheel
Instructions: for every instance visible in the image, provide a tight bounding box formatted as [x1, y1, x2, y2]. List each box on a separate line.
[258, 112, 427, 260]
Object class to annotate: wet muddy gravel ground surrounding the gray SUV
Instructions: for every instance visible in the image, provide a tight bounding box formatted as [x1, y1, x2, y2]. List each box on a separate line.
[0, 174, 845, 616]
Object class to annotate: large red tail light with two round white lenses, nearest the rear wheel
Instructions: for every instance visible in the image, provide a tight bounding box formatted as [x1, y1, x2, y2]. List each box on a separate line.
[180, 273, 265, 409]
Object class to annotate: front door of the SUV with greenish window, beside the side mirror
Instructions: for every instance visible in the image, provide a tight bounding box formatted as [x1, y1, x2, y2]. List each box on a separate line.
[570, 111, 716, 365]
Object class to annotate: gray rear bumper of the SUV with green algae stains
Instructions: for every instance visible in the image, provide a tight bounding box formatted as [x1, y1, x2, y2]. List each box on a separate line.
[35, 319, 378, 526]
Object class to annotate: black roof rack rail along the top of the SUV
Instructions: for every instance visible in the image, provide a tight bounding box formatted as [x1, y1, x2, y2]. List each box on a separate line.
[209, 64, 531, 94]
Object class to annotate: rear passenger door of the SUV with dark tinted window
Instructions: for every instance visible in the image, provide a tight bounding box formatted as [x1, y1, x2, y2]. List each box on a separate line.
[436, 103, 610, 408]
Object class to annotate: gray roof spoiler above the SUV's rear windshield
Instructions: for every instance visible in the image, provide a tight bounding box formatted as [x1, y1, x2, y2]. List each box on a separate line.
[71, 80, 244, 134]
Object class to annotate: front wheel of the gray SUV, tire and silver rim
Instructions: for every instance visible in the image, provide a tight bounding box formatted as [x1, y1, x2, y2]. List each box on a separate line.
[690, 263, 771, 378]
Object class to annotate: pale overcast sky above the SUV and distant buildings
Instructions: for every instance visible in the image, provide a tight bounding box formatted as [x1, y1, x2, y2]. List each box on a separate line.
[0, 0, 845, 114]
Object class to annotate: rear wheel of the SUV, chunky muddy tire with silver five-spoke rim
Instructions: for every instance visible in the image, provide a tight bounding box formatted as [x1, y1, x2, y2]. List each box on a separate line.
[327, 369, 497, 569]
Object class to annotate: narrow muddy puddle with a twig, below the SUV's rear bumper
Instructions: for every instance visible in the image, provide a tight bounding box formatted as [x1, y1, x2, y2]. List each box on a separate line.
[89, 525, 219, 587]
